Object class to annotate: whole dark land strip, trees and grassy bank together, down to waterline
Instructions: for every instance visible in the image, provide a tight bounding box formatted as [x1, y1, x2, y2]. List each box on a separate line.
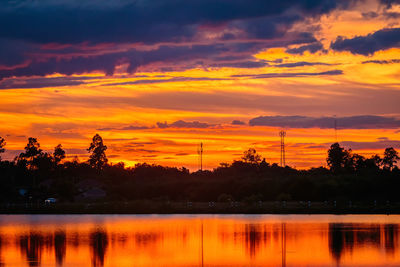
[0, 135, 400, 213]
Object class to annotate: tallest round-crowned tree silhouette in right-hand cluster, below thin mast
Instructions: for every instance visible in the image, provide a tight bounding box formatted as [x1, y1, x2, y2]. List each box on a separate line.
[326, 143, 354, 173]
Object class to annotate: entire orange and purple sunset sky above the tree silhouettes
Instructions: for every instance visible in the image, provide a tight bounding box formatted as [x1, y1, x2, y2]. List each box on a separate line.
[0, 0, 400, 170]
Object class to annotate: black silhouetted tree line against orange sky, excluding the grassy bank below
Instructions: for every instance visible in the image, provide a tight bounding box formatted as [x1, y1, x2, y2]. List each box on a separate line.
[0, 134, 400, 203]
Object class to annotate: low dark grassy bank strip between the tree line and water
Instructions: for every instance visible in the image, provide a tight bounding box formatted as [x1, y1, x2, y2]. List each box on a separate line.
[0, 200, 400, 214]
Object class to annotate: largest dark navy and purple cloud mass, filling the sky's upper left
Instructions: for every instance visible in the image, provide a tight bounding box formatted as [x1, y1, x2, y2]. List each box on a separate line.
[0, 0, 355, 79]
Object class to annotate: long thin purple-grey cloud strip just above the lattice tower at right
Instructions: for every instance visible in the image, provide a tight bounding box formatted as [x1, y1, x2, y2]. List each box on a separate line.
[249, 115, 400, 129]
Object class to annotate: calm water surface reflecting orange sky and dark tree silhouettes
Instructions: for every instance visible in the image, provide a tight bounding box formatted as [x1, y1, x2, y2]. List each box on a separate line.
[0, 215, 400, 267]
